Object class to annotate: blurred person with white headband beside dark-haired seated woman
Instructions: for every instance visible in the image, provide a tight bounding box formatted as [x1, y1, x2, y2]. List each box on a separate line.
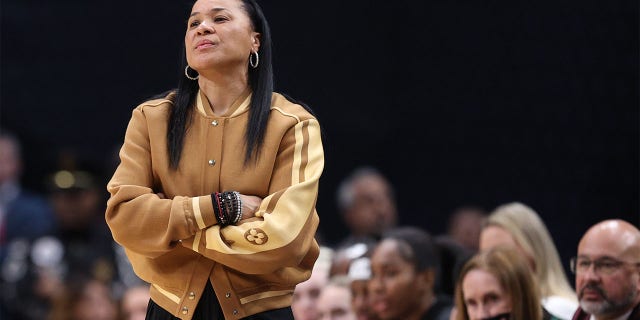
[348, 257, 378, 320]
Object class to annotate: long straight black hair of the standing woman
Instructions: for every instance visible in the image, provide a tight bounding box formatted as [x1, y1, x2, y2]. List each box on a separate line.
[167, 0, 273, 169]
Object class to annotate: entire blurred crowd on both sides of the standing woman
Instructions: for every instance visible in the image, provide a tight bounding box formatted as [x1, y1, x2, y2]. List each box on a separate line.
[0, 133, 640, 320]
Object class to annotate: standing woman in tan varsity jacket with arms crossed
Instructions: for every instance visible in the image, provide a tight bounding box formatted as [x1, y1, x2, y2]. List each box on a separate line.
[106, 0, 324, 319]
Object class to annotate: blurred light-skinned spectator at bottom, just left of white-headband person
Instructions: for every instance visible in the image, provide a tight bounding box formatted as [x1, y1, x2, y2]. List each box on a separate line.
[317, 276, 356, 320]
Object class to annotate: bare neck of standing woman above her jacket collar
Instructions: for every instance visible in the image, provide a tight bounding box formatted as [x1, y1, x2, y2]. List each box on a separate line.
[198, 68, 248, 116]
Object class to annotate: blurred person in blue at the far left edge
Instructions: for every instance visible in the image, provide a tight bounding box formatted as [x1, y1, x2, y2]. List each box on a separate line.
[0, 131, 54, 319]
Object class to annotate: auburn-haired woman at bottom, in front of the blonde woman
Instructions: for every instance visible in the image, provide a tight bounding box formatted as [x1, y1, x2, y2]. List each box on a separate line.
[455, 247, 543, 320]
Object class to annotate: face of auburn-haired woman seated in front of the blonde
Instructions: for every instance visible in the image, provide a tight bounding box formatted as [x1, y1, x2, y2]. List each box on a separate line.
[462, 269, 511, 320]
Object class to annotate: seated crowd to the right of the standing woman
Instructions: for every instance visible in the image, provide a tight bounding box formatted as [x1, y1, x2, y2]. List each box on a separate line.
[292, 168, 640, 320]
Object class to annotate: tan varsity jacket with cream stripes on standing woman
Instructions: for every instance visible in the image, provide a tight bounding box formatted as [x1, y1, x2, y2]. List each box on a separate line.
[105, 92, 324, 319]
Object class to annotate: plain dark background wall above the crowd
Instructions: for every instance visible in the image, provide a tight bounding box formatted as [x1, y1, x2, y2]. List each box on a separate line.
[0, 0, 640, 270]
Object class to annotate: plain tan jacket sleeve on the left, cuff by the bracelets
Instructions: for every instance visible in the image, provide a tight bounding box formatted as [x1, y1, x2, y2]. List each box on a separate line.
[105, 106, 215, 257]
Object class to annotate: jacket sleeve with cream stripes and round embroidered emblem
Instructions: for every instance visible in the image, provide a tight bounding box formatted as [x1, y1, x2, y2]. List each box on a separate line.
[182, 119, 324, 274]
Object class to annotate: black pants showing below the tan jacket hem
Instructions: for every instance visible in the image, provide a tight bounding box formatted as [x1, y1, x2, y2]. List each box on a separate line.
[145, 281, 293, 320]
